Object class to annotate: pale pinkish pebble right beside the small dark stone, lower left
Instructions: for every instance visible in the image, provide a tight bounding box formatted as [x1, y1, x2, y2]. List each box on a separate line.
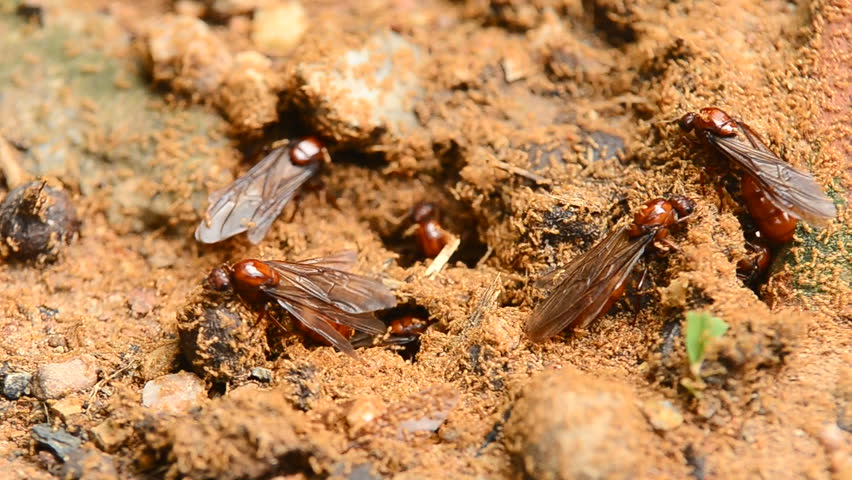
[33, 355, 98, 400]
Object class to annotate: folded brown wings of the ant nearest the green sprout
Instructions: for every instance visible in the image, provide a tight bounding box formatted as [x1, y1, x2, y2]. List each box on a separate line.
[524, 228, 654, 342]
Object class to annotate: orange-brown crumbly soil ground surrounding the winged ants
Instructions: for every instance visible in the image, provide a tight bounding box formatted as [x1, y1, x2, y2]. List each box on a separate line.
[0, 0, 852, 480]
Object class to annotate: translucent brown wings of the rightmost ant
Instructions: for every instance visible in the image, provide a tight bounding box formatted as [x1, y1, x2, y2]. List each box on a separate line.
[707, 122, 837, 226]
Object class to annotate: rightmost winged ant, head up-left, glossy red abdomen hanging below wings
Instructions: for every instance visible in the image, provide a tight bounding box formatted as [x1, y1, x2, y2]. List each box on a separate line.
[678, 107, 837, 243]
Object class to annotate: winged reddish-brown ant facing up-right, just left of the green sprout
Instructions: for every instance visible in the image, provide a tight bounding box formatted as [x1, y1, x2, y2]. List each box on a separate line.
[524, 195, 695, 342]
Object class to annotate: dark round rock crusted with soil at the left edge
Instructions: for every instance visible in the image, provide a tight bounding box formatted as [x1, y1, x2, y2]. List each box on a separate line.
[0, 181, 79, 262]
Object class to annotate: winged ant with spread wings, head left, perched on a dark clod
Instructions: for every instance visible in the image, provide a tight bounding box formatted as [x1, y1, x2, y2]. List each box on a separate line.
[206, 252, 396, 357]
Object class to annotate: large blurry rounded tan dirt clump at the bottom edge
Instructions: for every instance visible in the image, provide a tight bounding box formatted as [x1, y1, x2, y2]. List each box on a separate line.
[505, 369, 651, 479]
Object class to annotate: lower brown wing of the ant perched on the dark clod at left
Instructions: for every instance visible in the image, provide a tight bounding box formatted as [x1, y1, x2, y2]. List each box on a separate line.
[262, 279, 387, 335]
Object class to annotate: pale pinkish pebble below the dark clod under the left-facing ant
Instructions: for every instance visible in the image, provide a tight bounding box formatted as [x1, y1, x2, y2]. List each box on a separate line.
[142, 372, 207, 415]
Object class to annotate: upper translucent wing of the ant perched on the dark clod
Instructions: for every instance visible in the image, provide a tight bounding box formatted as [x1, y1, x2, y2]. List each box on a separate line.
[266, 256, 396, 316]
